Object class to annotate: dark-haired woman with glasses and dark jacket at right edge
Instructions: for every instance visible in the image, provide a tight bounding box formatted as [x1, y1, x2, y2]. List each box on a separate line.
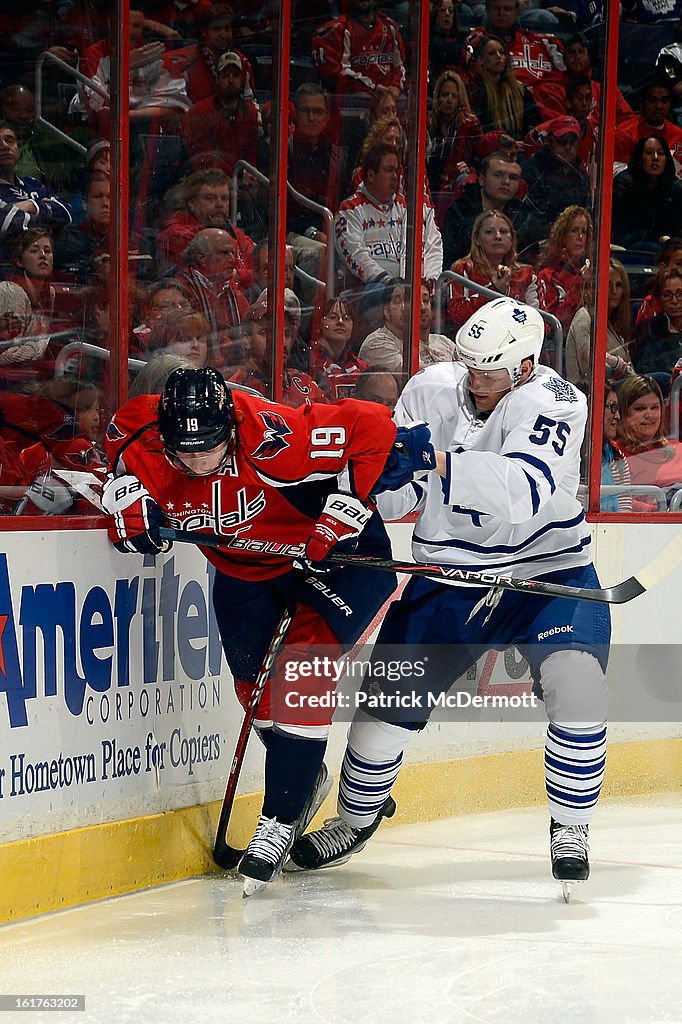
[632, 267, 682, 378]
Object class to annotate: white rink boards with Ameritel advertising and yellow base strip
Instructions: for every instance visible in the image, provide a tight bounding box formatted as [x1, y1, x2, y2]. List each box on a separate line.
[0, 524, 682, 922]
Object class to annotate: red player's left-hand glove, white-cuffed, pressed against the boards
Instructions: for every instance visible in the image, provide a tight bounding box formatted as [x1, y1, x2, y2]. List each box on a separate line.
[101, 476, 170, 555]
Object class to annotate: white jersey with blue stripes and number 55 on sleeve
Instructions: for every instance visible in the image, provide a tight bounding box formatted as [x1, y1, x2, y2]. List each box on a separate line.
[379, 362, 591, 580]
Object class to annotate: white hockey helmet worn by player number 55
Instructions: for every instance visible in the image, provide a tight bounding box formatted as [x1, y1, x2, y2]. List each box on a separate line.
[455, 296, 545, 387]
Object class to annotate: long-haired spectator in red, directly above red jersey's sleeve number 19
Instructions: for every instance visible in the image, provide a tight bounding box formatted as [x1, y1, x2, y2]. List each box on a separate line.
[309, 298, 368, 398]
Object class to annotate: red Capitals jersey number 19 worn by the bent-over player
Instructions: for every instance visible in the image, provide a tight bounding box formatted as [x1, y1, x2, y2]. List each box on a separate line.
[106, 391, 395, 581]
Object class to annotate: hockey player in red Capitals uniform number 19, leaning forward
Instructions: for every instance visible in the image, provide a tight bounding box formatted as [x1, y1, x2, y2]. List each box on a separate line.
[102, 368, 425, 894]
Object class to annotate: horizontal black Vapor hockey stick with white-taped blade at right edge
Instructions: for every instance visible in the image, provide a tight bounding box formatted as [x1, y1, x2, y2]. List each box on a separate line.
[156, 526, 682, 604]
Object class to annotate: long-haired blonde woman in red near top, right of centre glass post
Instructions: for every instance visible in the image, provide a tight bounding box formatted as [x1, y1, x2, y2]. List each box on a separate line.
[426, 71, 482, 200]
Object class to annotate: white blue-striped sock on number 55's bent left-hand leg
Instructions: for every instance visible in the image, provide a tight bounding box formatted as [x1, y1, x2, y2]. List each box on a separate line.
[338, 712, 414, 828]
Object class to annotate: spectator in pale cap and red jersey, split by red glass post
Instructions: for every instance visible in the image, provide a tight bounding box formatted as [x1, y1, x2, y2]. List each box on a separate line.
[227, 302, 329, 409]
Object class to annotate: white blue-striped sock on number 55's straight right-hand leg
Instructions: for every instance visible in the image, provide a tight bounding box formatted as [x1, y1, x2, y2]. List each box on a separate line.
[545, 722, 606, 825]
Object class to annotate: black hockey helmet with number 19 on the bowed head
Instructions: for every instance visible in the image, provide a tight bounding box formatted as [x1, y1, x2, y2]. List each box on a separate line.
[159, 367, 235, 453]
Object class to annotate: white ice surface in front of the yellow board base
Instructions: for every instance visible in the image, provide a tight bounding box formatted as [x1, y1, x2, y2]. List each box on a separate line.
[0, 796, 682, 1024]
